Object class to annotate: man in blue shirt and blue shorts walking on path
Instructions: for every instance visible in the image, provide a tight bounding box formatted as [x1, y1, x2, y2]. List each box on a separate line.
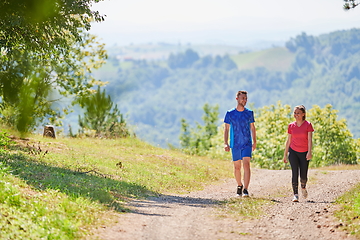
[224, 91, 256, 197]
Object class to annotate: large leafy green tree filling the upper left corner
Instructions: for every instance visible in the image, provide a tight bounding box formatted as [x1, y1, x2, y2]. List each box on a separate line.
[0, 0, 106, 135]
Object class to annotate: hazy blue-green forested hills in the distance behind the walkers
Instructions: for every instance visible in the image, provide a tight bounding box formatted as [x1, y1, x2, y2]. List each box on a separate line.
[97, 29, 360, 147]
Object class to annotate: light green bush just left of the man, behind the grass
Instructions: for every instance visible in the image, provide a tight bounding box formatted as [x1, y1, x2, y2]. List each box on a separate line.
[180, 103, 219, 155]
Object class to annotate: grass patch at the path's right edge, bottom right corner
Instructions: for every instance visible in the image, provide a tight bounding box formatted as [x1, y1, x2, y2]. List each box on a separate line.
[335, 184, 360, 239]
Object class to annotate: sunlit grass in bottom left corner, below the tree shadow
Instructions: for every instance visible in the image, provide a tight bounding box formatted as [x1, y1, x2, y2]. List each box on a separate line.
[0, 162, 111, 239]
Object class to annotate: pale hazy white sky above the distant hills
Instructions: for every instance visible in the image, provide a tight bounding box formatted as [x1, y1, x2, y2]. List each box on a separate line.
[91, 0, 360, 46]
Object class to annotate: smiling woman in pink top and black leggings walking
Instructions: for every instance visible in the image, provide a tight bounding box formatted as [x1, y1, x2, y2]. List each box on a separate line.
[283, 105, 314, 202]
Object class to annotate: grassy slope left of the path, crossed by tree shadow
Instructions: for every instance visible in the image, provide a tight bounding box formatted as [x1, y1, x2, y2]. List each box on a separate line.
[0, 132, 231, 239]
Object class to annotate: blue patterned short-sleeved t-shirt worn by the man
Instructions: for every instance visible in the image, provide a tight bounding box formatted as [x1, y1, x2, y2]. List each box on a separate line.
[224, 108, 255, 149]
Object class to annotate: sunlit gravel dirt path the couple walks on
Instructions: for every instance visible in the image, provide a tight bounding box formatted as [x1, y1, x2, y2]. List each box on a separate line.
[96, 169, 360, 240]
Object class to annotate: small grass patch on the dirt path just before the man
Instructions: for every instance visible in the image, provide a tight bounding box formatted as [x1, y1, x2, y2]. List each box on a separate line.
[219, 197, 274, 220]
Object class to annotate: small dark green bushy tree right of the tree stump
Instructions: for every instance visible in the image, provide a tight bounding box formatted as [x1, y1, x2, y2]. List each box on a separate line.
[79, 86, 129, 137]
